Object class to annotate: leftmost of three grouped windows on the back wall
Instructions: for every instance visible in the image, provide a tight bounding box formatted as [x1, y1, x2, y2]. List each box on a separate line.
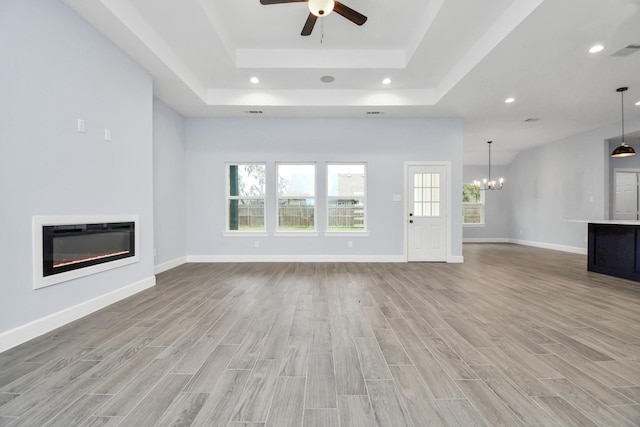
[226, 163, 266, 232]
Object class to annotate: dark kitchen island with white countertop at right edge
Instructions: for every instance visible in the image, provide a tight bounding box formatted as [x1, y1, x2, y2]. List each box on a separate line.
[587, 220, 640, 281]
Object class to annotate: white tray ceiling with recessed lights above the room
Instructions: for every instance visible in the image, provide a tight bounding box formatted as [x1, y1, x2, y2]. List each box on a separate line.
[64, 0, 640, 164]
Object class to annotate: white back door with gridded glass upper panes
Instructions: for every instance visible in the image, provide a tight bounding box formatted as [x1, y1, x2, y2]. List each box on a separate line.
[407, 165, 448, 261]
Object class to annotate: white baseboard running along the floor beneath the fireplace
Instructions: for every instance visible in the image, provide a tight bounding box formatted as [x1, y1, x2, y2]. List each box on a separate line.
[0, 276, 156, 352]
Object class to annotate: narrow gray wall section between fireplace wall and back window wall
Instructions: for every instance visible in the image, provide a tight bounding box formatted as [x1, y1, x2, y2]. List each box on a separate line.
[153, 99, 187, 265]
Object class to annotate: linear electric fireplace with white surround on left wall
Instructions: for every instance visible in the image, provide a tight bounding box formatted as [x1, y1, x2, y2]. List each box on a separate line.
[33, 216, 139, 289]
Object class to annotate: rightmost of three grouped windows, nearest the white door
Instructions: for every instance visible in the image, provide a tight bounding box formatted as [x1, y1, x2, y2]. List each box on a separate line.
[327, 163, 367, 231]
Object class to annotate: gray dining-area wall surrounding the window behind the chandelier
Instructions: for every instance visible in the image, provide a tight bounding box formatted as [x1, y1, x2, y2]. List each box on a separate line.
[463, 165, 512, 241]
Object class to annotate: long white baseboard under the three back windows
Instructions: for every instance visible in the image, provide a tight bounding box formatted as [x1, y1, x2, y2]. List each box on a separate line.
[187, 255, 406, 263]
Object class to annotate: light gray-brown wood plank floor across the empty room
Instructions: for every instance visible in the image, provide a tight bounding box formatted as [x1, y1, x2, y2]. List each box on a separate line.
[0, 244, 640, 427]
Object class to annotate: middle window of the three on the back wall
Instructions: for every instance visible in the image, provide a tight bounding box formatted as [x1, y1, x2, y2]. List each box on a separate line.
[277, 164, 316, 231]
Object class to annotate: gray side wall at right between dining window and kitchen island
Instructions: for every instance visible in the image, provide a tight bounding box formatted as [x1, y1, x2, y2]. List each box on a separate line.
[508, 118, 640, 249]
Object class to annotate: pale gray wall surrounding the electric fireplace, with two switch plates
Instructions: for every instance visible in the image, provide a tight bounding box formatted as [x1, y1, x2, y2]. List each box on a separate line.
[0, 0, 153, 333]
